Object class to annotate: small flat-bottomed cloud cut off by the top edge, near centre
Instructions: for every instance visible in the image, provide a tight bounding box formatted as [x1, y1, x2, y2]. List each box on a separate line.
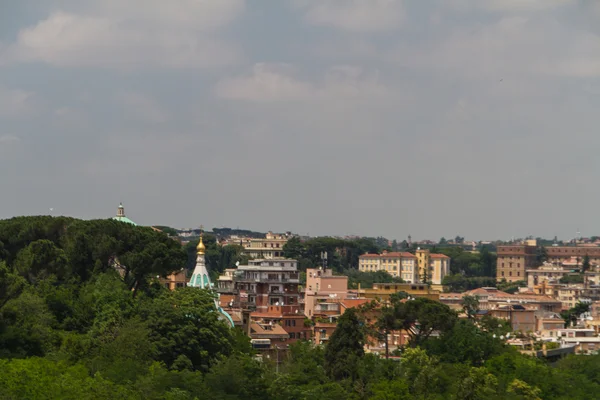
[295, 0, 405, 32]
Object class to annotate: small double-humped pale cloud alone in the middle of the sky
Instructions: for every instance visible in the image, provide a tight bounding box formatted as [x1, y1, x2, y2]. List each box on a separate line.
[215, 63, 385, 102]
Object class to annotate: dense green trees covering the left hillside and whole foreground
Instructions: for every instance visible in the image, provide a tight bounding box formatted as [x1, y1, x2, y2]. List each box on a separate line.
[0, 217, 600, 400]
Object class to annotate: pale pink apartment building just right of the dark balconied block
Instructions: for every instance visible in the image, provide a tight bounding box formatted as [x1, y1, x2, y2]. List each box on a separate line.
[303, 268, 348, 318]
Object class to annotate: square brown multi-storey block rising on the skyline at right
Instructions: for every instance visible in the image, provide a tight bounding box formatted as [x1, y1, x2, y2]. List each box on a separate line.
[496, 240, 537, 282]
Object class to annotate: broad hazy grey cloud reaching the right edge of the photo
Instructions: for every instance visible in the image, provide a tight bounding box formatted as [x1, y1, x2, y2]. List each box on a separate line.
[390, 16, 600, 79]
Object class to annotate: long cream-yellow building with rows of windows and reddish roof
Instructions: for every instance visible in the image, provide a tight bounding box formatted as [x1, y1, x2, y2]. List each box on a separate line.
[358, 249, 450, 285]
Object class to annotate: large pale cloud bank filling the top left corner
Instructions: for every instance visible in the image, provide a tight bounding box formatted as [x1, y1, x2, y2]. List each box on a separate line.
[0, 0, 244, 69]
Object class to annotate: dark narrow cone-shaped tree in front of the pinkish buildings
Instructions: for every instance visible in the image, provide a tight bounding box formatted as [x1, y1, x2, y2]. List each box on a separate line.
[325, 308, 365, 380]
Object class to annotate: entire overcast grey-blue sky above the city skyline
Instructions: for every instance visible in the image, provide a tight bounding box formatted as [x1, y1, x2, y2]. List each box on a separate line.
[0, 0, 600, 240]
